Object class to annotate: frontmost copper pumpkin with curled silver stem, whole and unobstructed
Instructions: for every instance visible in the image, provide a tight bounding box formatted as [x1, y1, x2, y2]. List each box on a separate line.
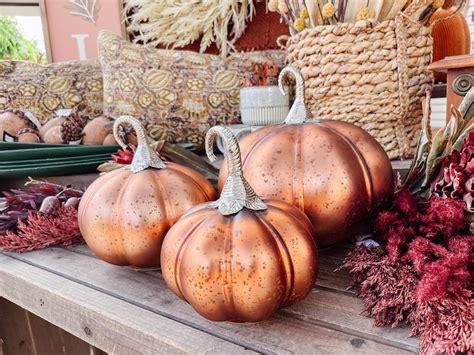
[161, 127, 317, 322]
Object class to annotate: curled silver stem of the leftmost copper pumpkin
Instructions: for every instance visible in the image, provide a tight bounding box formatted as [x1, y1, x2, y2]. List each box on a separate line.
[113, 116, 166, 173]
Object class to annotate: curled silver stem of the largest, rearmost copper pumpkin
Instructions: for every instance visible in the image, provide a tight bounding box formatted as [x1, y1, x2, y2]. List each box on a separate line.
[278, 66, 310, 124]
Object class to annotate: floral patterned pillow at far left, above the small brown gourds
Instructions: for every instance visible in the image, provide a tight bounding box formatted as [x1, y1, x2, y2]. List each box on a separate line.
[0, 60, 103, 123]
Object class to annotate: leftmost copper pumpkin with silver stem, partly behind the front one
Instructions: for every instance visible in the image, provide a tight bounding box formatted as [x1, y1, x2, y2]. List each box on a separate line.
[79, 116, 216, 267]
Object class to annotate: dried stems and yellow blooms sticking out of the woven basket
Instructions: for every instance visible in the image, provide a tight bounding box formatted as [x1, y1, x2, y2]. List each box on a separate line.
[267, 0, 460, 34]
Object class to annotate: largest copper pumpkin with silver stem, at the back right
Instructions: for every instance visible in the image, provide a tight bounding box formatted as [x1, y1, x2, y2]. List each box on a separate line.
[219, 67, 394, 247]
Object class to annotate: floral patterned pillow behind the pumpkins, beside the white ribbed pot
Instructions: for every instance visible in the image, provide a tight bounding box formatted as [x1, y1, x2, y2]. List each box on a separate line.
[99, 31, 285, 150]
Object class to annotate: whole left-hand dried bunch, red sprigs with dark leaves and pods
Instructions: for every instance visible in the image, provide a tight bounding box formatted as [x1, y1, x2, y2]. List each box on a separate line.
[0, 178, 83, 253]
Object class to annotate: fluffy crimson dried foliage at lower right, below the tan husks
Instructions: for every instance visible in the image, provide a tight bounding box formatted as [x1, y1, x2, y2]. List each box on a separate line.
[343, 190, 474, 354]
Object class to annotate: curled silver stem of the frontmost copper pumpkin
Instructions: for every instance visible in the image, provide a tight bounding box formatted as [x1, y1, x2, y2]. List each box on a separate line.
[206, 126, 267, 216]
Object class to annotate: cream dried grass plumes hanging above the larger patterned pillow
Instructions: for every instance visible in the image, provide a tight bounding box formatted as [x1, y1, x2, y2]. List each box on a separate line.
[124, 0, 255, 56]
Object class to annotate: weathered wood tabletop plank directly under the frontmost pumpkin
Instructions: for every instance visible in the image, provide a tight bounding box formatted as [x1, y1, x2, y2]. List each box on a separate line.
[7, 249, 414, 354]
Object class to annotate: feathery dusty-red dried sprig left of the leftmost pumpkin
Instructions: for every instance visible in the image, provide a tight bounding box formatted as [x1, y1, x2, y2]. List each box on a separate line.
[0, 205, 84, 253]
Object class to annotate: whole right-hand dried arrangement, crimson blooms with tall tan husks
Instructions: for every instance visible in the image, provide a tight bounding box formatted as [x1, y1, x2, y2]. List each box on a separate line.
[343, 90, 474, 354]
